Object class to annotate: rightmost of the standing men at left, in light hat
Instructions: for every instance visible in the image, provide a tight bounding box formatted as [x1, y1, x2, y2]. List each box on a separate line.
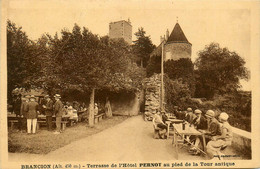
[53, 94, 63, 134]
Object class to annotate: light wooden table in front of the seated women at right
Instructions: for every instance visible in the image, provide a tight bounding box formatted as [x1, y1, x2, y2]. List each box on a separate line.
[172, 124, 206, 159]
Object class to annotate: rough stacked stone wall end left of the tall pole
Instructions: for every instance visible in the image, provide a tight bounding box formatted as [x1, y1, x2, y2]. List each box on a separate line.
[144, 74, 161, 114]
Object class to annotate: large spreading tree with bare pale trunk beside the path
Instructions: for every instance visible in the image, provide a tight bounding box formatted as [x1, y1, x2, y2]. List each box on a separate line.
[44, 24, 140, 126]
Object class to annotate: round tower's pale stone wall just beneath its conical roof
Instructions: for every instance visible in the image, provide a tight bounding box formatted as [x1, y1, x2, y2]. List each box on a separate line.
[164, 42, 191, 61]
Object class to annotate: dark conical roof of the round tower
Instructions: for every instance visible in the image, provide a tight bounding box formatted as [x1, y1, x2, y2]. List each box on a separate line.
[166, 23, 190, 43]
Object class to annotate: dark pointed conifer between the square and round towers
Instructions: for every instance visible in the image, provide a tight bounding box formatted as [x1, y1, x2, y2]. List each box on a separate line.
[133, 27, 155, 67]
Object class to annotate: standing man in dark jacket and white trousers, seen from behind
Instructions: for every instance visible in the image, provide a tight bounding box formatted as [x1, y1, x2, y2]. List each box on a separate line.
[26, 95, 39, 134]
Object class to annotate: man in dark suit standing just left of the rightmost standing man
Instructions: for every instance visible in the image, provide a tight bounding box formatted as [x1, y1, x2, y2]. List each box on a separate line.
[43, 95, 53, 131]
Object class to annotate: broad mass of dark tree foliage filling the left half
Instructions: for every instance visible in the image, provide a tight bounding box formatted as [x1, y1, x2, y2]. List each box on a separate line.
[7, 21, 144, 99]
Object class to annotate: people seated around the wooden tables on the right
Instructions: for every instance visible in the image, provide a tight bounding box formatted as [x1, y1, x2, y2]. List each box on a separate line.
[153, 107, 232, 159]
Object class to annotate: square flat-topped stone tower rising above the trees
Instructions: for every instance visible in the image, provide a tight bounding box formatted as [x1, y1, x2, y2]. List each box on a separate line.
[109, 20, 132, 44]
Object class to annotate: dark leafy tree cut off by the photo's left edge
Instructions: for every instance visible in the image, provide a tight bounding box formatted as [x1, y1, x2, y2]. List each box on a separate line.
[7, 20, 39, 100]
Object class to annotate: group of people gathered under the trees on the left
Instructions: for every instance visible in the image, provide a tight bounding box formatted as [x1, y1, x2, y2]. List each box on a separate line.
[10, 94, 84, 134]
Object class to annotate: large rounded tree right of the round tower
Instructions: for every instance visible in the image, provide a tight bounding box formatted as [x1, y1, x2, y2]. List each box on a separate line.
[195, 43, 249, 98]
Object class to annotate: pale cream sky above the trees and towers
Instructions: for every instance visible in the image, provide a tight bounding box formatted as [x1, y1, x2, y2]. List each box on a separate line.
[7, 0, 254, 90]
